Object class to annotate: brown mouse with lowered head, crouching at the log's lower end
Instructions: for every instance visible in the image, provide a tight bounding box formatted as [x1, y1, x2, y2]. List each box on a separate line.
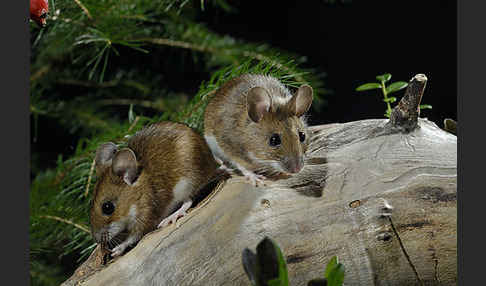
[90, 122, 218, 257]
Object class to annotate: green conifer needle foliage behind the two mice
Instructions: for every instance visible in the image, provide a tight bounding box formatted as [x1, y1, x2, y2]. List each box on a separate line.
[29, 0, 327, 285]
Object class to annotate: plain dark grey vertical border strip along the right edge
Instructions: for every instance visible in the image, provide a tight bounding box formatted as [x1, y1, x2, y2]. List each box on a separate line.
[457, 1, 480, 285]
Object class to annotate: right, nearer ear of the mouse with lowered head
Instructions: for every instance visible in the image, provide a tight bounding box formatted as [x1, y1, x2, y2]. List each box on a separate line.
[111, 148, 138, 185]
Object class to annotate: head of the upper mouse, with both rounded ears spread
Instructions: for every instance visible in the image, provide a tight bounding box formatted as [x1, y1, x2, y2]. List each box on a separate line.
[247, 85, 313, 174]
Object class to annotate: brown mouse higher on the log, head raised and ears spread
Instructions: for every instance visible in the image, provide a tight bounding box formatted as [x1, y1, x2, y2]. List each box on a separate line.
[204, 74, 313, 186]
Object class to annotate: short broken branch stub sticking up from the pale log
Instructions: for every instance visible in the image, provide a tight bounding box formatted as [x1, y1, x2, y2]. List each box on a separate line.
[389, 74, 427, 132]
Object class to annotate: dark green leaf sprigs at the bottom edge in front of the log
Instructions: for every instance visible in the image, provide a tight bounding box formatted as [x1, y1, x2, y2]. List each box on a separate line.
[242, 237, 344, 286]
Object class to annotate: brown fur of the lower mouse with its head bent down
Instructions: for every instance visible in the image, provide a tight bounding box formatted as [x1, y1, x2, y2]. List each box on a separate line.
[90, 122, 217, 249]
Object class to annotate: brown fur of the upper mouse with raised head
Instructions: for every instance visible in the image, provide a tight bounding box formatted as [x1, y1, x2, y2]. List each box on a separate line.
[204, 74, 309, 176]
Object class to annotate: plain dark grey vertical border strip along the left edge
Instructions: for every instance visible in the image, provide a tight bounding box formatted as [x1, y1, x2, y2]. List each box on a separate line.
[0, 1, 30, 285]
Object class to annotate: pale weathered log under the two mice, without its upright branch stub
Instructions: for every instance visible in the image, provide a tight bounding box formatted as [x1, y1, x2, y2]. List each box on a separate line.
[63, 115, 457, 285]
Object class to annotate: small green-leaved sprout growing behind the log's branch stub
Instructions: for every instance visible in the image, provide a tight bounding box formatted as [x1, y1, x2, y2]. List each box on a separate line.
[356, 73, 432, 118]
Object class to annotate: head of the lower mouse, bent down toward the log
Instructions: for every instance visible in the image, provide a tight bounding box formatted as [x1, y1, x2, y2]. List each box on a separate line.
[90, 142, 155, 248]
